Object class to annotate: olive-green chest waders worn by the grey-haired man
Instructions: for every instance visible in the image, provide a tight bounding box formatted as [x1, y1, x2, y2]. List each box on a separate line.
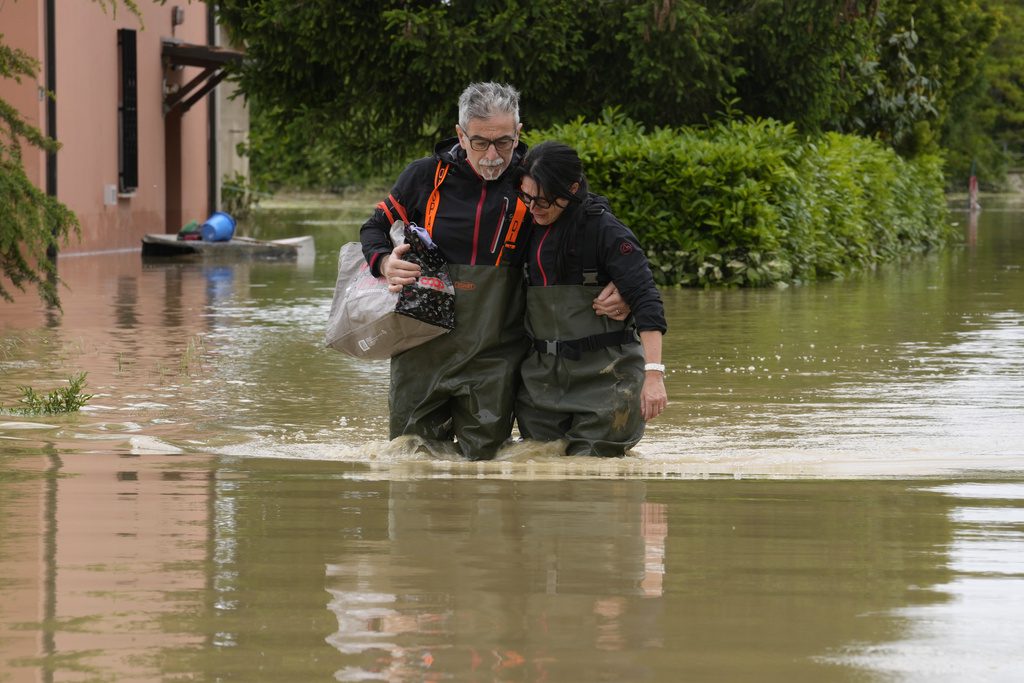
[388, 265, 526, 460]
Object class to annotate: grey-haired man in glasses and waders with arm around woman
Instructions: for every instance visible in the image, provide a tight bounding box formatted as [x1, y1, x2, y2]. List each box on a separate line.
[359, 83, 628, 460]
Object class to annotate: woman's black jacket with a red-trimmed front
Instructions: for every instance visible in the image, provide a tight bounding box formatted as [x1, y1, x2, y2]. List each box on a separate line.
[527, 195, 668, 333]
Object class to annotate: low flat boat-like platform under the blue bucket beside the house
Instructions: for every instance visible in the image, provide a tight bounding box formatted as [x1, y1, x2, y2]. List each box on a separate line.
[142, 233, 316, 262]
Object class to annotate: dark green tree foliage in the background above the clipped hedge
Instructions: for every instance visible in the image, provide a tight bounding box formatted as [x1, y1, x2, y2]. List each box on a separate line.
[218, 0, 995, 189]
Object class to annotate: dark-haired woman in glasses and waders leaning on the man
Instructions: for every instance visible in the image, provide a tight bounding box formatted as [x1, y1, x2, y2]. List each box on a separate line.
[516, 142, 668, 456]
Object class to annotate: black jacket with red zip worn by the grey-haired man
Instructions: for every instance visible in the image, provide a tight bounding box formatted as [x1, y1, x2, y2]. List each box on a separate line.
[359, 137, 529, 275]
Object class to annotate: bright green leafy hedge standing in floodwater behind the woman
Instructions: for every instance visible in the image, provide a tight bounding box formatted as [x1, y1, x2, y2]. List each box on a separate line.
[526, 111, 952, 286]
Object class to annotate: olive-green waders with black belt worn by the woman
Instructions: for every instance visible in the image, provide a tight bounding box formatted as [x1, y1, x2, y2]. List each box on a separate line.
[515, 285, 644, 456]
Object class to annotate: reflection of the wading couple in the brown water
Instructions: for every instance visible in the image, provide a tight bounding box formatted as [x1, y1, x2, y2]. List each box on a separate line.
[326, 481, 668, 681]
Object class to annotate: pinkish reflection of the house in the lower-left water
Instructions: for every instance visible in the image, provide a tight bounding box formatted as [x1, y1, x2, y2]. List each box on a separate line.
[0, 453, 209, 681]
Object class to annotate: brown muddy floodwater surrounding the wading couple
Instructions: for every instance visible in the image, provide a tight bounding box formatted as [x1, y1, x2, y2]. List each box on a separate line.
[0, 198, 1024, 683]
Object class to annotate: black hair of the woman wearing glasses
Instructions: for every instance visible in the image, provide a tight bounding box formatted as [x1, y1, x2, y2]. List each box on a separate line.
[513, 140, 589, 282]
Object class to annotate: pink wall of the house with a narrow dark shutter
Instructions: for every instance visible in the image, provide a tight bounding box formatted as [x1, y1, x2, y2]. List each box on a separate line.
[0, 0, 218, 254]
